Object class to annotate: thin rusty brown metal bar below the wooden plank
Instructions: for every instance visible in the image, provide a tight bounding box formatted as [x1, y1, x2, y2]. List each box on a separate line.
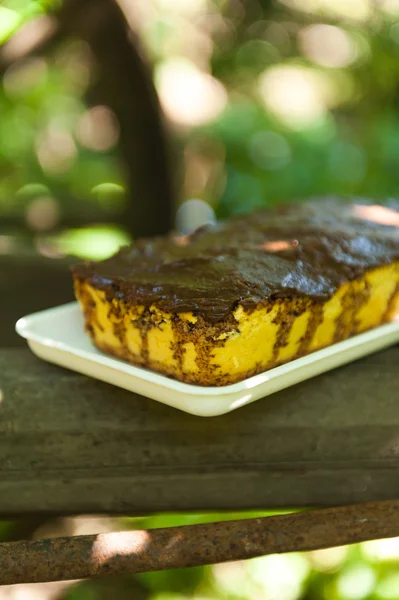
[0, 501, 399, 585]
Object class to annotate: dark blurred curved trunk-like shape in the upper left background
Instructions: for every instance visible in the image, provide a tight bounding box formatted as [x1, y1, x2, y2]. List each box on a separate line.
[0, 0, 174, 235]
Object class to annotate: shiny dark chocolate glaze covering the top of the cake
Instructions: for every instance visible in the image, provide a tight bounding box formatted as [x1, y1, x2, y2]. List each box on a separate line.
[72, 198, 399, 322]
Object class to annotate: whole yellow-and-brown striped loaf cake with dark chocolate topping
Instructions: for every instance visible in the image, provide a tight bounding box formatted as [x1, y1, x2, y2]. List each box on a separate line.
[72, 198, 399, 386]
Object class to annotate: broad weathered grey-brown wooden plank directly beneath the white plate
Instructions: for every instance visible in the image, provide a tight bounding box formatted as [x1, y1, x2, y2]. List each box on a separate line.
[0, 346, 399, 515]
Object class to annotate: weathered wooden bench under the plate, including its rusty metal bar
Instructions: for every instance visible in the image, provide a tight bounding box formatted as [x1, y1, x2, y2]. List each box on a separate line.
[0, 258, 399, 583]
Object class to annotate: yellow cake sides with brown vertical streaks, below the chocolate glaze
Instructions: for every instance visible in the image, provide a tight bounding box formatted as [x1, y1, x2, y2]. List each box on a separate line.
[75, 261, 399, 385]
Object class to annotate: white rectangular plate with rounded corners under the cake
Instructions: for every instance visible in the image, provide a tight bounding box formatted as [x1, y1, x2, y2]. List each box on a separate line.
[16, 302, 399, 417]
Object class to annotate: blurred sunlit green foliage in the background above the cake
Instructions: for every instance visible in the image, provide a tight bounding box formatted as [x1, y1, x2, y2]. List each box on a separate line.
[0, 0, 399, 246]
